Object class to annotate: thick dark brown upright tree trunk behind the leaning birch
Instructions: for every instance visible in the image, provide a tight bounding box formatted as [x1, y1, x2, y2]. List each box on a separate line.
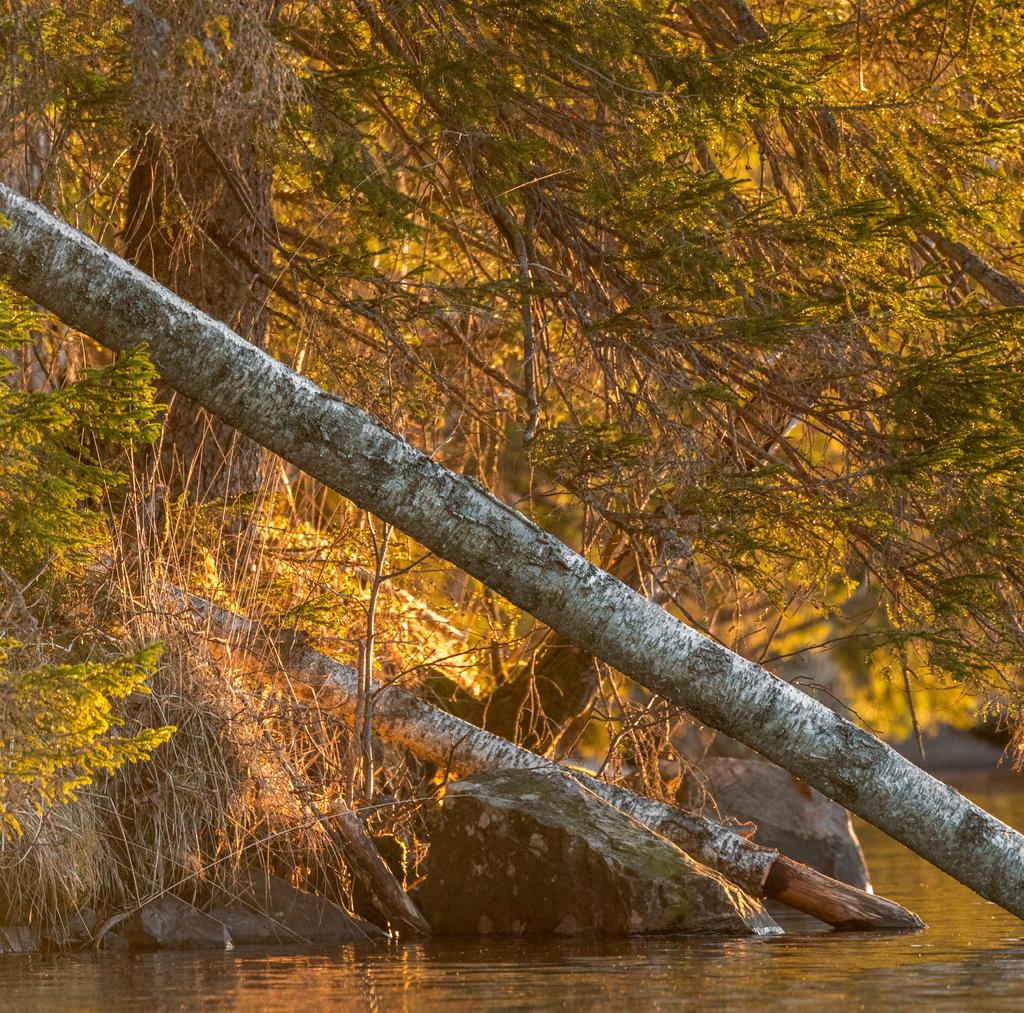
[123, 9, 272, 502]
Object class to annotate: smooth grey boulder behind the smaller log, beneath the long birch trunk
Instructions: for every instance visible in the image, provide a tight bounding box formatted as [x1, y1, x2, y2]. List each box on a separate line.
[689, 757, 870, 890]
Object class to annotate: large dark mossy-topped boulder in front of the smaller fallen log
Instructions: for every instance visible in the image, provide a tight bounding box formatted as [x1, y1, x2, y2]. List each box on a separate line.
[413, 770, 777, 935]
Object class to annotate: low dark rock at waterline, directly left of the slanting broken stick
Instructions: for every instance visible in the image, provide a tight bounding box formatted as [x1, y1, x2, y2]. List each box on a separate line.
[211, 870, 385, 945]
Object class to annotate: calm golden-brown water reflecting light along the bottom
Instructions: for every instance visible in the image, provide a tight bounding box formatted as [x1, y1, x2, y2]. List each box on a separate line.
[0, 774, 1024, 1013]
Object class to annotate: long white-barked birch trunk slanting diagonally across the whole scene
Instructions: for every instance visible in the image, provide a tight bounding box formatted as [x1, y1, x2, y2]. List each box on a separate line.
[0, 185, 1024, 917]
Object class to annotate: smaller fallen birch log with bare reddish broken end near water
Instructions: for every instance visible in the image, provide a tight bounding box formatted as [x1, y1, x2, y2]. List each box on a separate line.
[167, 589, 924, 931]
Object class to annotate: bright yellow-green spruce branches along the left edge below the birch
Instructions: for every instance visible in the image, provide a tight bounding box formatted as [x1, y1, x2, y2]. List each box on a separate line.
[0, 280, 173, 834]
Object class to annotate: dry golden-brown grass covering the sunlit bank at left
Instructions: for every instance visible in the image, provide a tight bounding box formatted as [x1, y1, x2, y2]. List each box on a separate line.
[0, 450, 448, 935]
